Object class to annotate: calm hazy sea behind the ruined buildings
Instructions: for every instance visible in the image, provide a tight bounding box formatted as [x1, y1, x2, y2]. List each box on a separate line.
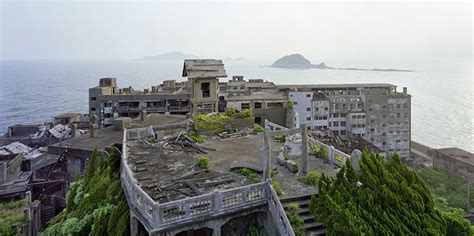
[0, 59, 474, 152]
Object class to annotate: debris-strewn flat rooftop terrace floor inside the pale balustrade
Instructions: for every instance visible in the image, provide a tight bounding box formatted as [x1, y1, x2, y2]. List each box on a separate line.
[127, 133, 337, 202]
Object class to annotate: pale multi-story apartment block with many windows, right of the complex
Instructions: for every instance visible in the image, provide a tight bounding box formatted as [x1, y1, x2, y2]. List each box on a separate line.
[279, 84, 411, 157]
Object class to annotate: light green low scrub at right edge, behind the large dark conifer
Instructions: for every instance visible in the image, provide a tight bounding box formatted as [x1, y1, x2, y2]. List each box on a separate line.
[418, 167, 474, 212]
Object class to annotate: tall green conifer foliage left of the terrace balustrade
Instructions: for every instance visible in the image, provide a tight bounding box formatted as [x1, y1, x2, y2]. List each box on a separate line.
[43, 149, 130, 235]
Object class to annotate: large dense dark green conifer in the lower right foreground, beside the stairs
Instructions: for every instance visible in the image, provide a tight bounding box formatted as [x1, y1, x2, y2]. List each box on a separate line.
[309, 151, 471, 235]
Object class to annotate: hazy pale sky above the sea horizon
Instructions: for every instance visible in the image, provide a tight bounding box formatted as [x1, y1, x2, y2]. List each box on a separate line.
[0, 1, 472, 59]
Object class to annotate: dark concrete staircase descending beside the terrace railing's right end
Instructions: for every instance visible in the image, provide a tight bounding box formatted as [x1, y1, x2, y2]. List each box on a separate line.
[280, 195, 326, 236]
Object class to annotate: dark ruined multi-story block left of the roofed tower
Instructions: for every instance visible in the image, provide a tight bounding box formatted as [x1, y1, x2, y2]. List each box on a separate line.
[89, 78, 191, 127]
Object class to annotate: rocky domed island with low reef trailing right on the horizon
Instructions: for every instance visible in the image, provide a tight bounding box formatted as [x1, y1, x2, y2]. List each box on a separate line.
[270, 54, 413, 72]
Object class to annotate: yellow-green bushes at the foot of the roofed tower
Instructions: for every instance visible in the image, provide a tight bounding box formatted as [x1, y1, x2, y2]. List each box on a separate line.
[193, 108, 253, 133]
